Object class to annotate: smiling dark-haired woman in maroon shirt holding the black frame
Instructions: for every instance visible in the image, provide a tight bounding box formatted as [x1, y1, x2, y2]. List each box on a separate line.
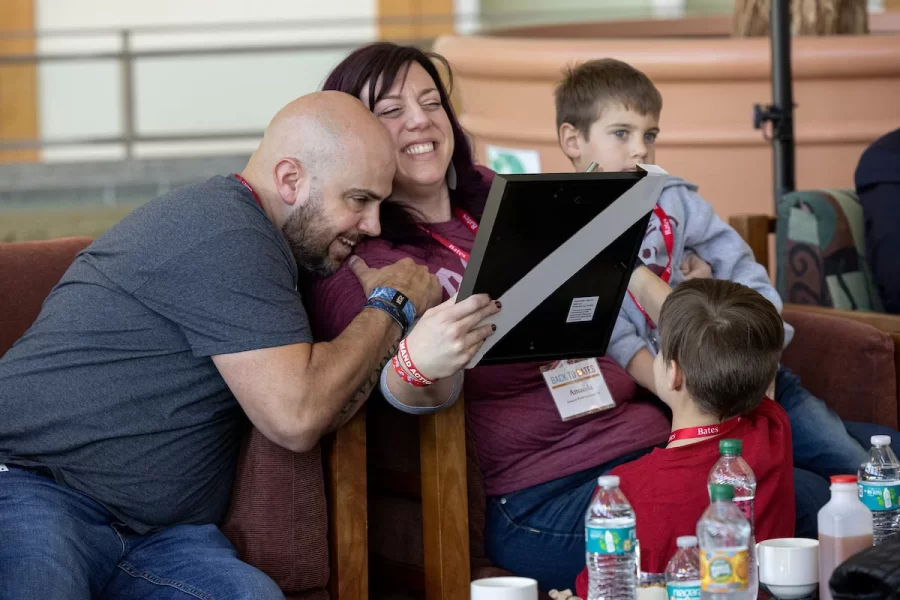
[310, 42, 669, 590]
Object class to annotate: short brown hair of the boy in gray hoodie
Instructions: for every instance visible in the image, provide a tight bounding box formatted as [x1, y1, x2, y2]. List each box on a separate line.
[555, 58, 662, 139]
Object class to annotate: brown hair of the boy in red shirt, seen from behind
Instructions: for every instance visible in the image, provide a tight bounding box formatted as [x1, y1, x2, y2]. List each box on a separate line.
[659, 279, 784, 419]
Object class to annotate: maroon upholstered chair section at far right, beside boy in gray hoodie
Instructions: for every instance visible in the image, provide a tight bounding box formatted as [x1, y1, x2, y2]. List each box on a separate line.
[783, 305, 900, 428]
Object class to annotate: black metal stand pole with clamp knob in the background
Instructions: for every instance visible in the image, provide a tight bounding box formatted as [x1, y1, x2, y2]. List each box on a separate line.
[753, 0, 795, 208]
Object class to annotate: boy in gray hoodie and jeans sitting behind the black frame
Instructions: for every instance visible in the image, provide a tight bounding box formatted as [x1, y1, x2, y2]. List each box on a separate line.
[556, 59, 898, 537]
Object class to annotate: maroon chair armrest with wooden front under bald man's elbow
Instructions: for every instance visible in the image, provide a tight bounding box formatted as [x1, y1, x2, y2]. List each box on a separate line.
[222, 407, 369, 600]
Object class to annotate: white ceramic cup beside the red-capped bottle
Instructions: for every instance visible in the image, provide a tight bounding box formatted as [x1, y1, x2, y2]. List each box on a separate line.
[756, 538, 819, 599]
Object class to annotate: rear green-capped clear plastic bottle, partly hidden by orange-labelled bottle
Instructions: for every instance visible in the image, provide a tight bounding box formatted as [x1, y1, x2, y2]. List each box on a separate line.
[707, 439, 759, 598]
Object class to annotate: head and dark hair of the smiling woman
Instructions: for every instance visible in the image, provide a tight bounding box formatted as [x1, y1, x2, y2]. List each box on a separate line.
[322, 42, 490, 244]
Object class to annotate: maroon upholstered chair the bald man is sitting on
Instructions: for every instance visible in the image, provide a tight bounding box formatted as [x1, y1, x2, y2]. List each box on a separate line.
[0, 238, 367, 600]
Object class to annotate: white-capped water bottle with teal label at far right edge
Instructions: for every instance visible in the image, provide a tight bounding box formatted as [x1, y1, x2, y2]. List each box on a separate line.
[858, 435, 900, 546]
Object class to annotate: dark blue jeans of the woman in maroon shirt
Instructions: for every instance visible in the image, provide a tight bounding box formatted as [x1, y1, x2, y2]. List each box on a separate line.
[484, 448, 653, 592]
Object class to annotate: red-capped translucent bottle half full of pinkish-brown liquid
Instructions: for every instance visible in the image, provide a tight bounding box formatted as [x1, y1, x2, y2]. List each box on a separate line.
[819, 475, 872, 600]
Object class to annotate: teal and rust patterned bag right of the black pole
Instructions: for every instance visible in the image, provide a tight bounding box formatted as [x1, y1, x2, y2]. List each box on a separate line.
[775, 190, 881, 311]
